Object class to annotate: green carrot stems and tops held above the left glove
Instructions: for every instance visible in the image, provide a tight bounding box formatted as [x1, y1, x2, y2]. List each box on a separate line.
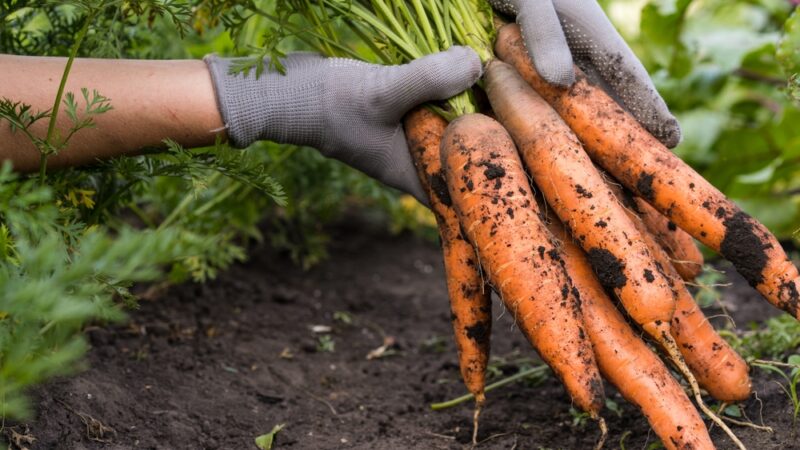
[244, 0, 494, 120]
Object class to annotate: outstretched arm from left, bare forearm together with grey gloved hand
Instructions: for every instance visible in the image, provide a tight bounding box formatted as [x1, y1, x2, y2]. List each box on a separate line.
[0, 47, 481, 202]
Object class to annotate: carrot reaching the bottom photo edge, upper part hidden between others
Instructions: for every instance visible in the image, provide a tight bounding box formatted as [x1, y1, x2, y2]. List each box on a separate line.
[548, 214, 714, 450]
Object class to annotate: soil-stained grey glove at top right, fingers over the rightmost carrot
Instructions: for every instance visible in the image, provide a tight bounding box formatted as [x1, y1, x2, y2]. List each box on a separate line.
[489, 0, 681, 148]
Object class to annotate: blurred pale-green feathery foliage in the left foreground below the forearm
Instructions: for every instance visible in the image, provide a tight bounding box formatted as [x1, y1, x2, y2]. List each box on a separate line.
[0, 164, 231, 418]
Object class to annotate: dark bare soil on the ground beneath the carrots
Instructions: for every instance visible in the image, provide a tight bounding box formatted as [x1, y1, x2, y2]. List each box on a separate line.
[6, 218, 800, 449]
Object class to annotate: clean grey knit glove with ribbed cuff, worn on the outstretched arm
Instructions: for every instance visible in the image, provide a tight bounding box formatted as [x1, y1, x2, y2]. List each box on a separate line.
[205, 47, 482, 204]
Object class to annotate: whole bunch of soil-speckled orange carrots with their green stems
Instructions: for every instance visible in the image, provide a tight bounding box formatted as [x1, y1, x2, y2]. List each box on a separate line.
[274, 0, 800, 449]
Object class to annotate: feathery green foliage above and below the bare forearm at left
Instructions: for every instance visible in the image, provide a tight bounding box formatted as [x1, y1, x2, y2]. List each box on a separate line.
[0, 0, 430, 419]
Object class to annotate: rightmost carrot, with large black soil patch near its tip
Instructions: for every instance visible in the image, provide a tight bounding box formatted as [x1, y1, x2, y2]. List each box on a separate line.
[495, 25, 800, 318]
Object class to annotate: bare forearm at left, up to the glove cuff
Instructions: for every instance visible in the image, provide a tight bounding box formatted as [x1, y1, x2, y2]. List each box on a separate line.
[0, 55, 224, 171]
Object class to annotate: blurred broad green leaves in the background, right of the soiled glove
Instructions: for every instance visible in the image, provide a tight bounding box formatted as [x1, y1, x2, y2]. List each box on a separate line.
[620, 0, 800, 238]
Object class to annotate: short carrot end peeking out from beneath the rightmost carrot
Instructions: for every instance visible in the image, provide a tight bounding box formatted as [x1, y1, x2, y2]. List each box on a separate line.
[634, 197, 704, 281]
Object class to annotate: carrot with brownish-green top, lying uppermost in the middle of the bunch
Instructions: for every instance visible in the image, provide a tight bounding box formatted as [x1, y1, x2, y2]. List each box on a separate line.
[485, 61, 675, 339]
